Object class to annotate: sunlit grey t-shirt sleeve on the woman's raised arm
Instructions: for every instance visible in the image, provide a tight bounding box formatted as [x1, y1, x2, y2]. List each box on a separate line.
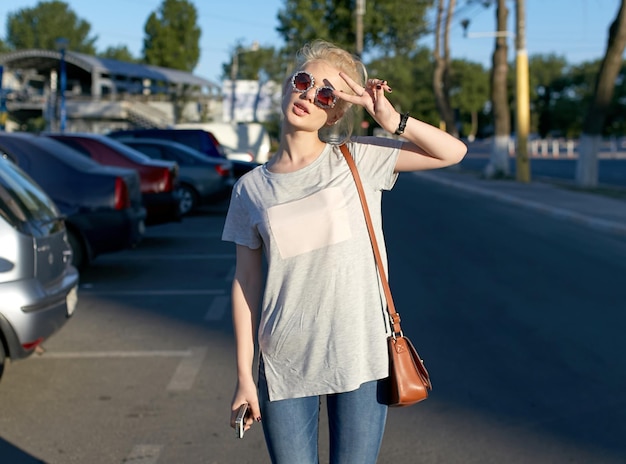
[348, 137, 403, 190]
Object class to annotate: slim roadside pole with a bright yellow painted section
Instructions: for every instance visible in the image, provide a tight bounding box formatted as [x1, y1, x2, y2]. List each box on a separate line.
[515, 0, 530, 182]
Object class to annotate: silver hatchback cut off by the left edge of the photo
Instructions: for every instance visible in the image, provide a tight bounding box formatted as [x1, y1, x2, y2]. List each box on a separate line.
[0, 157, 78, 377]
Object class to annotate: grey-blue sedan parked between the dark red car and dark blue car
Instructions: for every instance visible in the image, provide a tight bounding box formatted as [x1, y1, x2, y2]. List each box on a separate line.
[118, 137, 235, 215]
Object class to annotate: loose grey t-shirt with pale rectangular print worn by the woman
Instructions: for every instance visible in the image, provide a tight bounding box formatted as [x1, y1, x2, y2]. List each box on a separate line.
[222, 138, 401, 401]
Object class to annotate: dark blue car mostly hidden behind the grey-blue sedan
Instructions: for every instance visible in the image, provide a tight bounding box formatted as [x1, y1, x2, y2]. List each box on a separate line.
[107, 129, 259, 179]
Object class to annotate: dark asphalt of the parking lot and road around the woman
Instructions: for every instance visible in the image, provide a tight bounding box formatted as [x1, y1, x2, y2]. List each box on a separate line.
[0, 174, 626, 464]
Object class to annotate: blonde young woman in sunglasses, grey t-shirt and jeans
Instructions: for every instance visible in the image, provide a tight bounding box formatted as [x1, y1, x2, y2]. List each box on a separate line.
[223, 41, 466, 464]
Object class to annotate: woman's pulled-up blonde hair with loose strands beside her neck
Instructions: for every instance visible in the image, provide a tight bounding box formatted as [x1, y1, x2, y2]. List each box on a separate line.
[296, 40, 367, 145]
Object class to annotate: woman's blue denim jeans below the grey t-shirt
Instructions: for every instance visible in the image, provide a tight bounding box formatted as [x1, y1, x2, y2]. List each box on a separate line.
[259, 361, 387, 464]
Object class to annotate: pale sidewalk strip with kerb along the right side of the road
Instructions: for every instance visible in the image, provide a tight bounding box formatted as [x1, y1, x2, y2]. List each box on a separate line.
[415, 168, 626, 237]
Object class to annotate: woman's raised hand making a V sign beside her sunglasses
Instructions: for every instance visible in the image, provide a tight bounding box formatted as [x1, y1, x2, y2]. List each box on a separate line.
[335, 72, 398, 132]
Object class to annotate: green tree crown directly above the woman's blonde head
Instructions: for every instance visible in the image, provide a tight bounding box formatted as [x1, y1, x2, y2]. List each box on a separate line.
[277, 0, 433, 55]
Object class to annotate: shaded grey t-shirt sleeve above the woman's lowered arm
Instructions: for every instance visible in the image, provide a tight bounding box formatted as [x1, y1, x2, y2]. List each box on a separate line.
[222, 184, 262, 249]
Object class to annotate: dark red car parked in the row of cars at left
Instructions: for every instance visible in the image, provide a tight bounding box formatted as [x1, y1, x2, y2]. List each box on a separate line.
[45, 133, 181, 225]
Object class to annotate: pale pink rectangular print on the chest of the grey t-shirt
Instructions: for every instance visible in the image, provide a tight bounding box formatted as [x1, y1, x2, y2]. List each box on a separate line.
[267, 187, 352, 259]
